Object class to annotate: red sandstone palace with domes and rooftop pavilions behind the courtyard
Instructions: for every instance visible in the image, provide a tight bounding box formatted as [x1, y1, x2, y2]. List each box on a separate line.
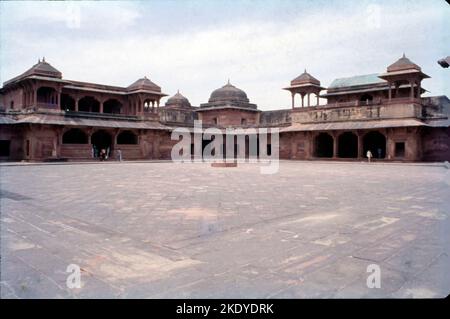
[0, 56, 450, 161]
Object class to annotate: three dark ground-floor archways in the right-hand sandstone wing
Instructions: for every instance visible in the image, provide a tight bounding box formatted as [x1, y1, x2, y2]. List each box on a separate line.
[314, 131, 386, 158]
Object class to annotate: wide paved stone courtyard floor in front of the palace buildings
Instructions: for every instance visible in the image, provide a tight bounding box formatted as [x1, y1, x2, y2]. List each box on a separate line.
[0, 161, 450, 298]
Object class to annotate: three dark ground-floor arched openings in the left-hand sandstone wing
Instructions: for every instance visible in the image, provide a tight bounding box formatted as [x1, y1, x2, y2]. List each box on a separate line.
[62, 128, 138, 149]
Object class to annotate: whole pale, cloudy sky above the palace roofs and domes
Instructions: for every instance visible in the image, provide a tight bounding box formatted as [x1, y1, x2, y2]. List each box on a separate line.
[0, 0, 450, 110]
